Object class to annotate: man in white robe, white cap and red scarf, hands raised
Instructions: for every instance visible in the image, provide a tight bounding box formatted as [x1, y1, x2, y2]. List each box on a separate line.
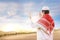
[32, 6, 54, 40]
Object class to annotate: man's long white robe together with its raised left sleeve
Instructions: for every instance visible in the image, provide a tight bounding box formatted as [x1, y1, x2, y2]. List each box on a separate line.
[32, 23, 53, 40]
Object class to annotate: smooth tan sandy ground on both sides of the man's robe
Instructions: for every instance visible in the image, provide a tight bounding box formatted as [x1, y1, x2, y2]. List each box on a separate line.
[0, 31, 60, 40]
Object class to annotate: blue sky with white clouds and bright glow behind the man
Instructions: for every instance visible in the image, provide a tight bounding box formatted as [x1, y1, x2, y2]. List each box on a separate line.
[0, 0, 60, 31]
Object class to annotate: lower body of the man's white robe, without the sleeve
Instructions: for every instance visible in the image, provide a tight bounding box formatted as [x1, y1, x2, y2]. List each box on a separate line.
[37, 30, 53, 40]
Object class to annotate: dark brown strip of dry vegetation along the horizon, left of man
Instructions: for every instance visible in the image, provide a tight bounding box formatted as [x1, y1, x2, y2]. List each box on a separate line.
[0, 31, 35, 37]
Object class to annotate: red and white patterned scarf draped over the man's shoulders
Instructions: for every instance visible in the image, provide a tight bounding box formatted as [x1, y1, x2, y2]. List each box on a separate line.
[38, 14, 54, 33]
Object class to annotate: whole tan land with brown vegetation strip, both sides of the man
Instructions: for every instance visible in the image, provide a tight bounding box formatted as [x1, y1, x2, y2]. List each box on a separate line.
[0, 29, 60, 40]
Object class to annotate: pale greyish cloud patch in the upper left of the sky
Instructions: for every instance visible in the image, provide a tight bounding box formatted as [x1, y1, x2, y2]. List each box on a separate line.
[7, 3, 18, 16]
